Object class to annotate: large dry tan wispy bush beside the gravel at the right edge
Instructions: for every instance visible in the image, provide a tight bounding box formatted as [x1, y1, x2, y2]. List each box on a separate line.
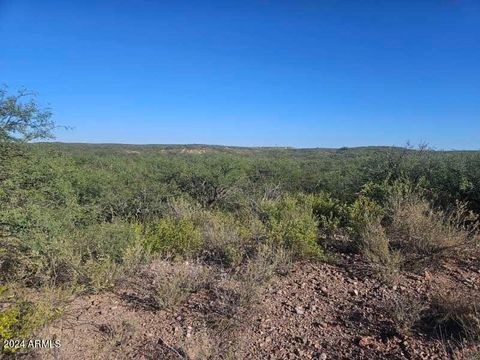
[353, 189, 479, 276]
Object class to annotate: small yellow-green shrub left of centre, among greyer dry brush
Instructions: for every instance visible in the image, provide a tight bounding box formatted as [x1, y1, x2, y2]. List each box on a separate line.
[145, 218, 202, 255]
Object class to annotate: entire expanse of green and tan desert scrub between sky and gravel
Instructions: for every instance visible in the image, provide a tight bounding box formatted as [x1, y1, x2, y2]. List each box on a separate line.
[0, 89, 480, 354]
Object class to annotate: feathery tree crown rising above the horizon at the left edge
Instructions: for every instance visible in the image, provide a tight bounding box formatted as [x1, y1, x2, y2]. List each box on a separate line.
[0, 86, 55, 143]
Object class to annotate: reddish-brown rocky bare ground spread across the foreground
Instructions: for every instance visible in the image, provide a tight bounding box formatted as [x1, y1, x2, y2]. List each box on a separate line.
[28, 248, 480, 359]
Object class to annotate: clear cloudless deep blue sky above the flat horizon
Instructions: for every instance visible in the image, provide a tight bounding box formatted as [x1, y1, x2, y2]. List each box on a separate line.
[0, 0, 480, 149]
